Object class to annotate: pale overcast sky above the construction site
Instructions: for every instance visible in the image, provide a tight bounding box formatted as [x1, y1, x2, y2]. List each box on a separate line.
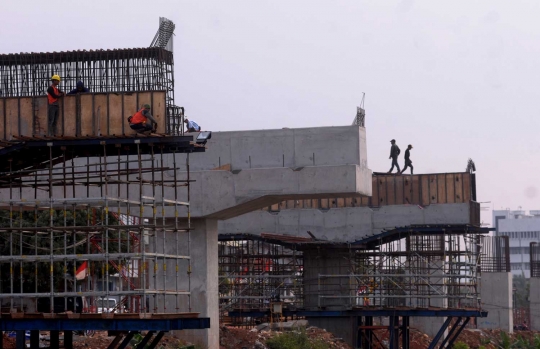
[0, 0, 540, 222]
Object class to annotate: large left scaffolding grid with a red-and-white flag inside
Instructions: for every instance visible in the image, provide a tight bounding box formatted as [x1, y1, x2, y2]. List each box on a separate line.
[0, 136, 196, 314]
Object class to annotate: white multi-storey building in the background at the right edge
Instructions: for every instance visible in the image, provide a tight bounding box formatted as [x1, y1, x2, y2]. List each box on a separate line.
[492, 209, 540, 278]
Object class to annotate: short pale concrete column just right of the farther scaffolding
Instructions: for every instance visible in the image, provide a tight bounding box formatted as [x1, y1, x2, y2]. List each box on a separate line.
[478, 272, 512, 333]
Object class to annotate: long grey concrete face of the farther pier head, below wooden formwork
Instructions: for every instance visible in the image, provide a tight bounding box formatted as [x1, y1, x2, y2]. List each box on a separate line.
[219, 203, 470, 242]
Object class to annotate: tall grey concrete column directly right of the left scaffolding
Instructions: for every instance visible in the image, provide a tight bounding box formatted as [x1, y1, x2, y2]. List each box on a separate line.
[168, 219, 219, 349]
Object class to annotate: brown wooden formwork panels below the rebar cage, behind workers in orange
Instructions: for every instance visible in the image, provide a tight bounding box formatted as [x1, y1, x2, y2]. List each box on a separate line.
[0, 91, 167, 141]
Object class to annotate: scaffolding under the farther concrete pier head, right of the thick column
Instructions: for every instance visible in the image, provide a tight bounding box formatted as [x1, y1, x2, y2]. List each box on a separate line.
[219, 225, 490, 325]
